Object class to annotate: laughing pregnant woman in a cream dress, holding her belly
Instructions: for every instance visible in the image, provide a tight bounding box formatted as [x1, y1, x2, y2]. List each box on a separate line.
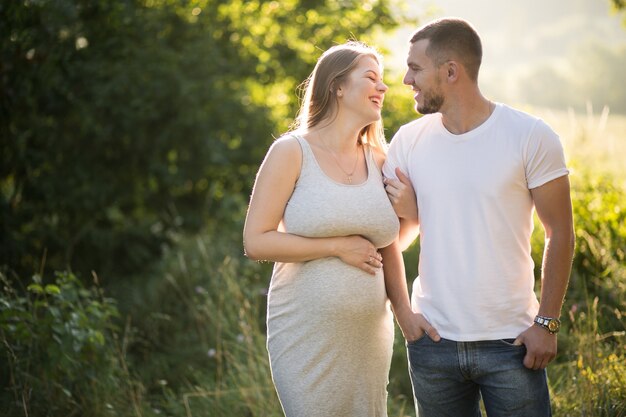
[244, 42, 399, 417]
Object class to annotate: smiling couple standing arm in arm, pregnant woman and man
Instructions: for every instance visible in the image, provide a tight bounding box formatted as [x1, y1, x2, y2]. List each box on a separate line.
[244, 18, 573, 417]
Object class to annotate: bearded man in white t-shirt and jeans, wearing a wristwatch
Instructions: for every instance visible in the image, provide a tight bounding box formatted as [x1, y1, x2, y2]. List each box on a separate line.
[384, 18, 574, 417]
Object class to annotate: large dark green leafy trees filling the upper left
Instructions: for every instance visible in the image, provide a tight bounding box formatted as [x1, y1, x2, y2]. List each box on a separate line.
[0, 0, 408, 279]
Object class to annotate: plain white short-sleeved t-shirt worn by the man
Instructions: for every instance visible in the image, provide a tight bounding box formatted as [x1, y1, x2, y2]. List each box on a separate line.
[383, 103, 568, 341]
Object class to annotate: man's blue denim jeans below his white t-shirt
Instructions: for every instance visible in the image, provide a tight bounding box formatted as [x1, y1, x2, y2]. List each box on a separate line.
[407, 335, 552, 417]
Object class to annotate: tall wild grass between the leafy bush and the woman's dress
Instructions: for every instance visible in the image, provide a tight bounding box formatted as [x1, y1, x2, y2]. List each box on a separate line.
[108, 229, 282, 417]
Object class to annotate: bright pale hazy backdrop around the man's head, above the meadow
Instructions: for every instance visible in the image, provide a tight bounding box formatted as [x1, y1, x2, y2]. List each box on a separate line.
[382, 0, 626, 114]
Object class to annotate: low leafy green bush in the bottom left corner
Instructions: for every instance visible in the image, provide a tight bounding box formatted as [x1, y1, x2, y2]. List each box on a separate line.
[0, 273, 139, 417]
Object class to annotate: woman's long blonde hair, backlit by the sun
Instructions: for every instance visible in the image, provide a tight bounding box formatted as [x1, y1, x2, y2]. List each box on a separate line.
[289, 41, 387, 152]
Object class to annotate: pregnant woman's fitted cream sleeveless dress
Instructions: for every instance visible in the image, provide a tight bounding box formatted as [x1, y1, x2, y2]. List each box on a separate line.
[267, 136, 399, 417]
